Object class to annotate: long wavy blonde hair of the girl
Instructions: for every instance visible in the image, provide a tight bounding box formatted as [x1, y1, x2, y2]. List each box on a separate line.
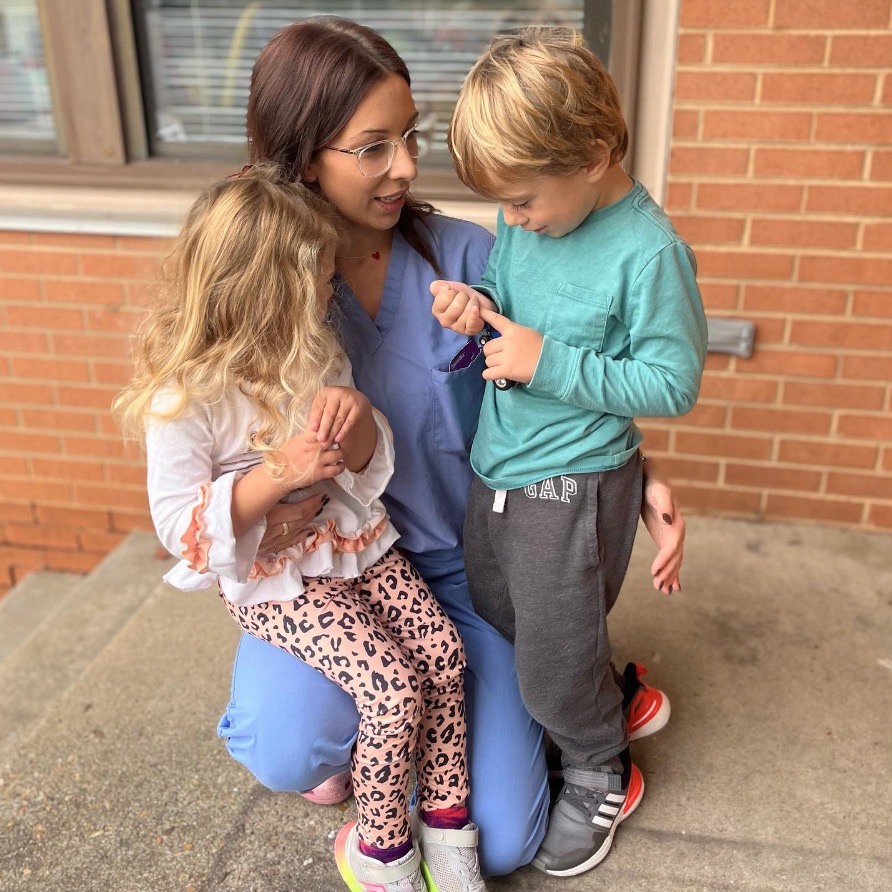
[114, 165, 342, 468]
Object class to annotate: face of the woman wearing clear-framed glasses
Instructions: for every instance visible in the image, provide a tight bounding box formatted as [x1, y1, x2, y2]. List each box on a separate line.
[304, 74, 418, 237]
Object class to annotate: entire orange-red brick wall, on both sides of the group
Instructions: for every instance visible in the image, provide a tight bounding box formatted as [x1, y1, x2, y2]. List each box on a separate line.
[0, 0, 892, 594]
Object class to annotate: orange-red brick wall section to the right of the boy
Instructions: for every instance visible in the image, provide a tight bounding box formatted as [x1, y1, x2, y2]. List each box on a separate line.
[645, 0, 892, 529]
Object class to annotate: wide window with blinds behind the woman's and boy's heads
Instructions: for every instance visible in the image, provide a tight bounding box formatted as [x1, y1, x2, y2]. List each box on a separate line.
[134, 0, 592, 167]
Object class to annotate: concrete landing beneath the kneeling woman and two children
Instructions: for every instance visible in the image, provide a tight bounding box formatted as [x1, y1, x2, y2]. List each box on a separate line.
[0, 517, 892, 892]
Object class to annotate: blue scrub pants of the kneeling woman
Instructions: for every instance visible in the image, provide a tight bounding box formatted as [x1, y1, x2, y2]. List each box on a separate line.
[217, 552, 548, 876]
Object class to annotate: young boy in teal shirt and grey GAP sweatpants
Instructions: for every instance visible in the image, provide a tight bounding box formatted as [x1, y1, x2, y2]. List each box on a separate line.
[431, 28, 706, 876]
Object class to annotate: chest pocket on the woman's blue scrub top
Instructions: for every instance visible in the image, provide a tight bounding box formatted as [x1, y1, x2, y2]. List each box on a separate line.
[430, 358, 486, 455]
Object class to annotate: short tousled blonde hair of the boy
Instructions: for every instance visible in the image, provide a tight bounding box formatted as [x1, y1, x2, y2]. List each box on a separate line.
[447, 27, 629, 198]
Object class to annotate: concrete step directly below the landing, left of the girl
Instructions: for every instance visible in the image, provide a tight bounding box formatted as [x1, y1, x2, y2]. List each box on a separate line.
[0, 532, 172, 764]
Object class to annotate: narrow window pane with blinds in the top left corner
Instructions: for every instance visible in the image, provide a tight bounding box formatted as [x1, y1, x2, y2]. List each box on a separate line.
[0, 0, 56, 152]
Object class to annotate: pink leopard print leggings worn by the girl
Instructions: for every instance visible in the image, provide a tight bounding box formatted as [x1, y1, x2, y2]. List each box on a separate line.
[224, 549, 468, 848]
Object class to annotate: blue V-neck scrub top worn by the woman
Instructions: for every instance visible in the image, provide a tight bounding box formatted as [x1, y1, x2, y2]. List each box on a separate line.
[336, 215, 494, 553]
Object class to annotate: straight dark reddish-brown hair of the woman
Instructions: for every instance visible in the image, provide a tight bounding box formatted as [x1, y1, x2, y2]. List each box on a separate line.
[247, 16, 442, 275]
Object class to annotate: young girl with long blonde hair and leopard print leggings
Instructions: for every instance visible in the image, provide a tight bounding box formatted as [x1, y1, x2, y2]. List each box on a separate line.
[116, 167, 485, 892]
